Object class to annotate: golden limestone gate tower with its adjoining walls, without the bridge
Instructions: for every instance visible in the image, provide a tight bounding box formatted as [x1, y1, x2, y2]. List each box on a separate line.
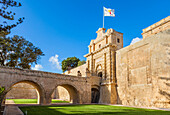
[64, 16, 170, 108]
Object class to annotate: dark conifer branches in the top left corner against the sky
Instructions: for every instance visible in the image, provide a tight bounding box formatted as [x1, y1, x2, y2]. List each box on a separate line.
[0, 0, 24, 36]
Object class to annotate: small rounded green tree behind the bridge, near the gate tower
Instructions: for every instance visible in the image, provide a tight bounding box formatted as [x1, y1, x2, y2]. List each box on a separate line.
[62, 57, 80, 72]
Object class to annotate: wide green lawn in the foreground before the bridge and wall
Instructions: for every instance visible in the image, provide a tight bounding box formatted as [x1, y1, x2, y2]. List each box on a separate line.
[19, 105, 170, 115]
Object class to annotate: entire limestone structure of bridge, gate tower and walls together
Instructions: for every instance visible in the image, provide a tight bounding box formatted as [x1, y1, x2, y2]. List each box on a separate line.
[0, 16, 170, 108]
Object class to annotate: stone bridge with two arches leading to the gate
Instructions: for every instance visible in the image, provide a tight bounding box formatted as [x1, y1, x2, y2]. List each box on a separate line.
[0, 67, 91, 105]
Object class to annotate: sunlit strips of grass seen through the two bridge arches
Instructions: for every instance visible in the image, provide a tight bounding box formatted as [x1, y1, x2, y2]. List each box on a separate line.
[7, 99, 69, 104]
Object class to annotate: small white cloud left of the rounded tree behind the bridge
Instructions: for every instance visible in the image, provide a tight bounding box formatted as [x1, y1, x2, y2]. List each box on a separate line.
[49, 54, 61, 70]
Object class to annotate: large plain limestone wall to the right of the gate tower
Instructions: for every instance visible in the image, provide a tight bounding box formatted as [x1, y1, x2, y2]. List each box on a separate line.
[116, 29, 170, 108]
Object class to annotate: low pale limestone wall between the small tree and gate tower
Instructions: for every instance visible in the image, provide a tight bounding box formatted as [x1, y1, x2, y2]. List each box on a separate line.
[65, 64, 86, 77]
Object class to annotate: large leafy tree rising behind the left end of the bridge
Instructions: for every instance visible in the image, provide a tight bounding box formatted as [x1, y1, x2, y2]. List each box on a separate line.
[0, 35, 44, 69]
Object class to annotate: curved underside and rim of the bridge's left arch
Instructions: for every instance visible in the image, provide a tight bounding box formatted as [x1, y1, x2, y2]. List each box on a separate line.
[6, 80, 45, 104]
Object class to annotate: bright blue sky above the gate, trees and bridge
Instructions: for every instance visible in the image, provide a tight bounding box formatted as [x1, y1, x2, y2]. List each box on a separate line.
[7, 0, 170, 73]
